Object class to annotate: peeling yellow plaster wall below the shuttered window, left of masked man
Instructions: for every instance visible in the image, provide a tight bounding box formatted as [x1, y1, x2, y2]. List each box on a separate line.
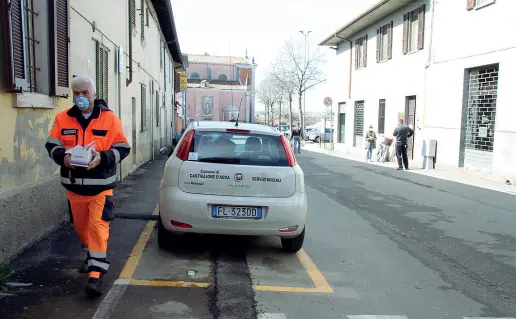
[0, 92, 72, 194]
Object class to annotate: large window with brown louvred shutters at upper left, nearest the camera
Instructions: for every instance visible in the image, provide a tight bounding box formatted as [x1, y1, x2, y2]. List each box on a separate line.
[0, 0, 71, 97]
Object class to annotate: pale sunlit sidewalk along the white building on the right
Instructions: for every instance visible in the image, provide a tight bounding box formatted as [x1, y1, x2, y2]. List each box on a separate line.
[303, 142, 516, 195]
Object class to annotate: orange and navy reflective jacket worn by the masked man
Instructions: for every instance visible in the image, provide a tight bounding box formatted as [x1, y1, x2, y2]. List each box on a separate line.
[45, 100, 130, 196]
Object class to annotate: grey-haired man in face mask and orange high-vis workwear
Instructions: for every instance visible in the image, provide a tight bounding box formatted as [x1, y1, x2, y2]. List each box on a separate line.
[45, 76, 130, 296]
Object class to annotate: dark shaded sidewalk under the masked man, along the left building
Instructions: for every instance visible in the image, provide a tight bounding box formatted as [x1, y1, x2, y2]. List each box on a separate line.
[0, 156, 168, 319]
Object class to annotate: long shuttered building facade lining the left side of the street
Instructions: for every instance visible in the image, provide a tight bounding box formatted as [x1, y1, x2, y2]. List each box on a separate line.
[0, 0, 182, 263]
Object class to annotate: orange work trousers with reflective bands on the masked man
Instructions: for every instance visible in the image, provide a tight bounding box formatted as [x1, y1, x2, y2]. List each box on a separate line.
[67, 190, 113, 278]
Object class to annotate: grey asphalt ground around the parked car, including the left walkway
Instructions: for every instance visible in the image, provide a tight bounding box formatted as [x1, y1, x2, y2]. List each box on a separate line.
[0, 152, 516, 319]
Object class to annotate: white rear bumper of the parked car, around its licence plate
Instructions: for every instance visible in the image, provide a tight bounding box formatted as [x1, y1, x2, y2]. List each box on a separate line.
[159, 186, 307, 238]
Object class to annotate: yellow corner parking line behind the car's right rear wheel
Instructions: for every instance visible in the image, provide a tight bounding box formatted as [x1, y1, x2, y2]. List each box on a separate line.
[254, 249, 333, 294]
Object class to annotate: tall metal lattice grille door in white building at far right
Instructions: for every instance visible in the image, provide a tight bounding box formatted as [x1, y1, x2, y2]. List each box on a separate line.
[462, 65, 499, 173]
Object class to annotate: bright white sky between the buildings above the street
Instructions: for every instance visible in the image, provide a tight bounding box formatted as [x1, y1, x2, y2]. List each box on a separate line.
[171, 0, 379, 112]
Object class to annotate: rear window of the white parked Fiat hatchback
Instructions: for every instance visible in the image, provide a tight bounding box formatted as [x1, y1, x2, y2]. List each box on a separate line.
[188, 131, 289, 166]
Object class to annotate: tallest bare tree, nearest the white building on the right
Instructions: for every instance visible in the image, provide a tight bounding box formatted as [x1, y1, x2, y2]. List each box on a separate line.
[276, 40, 326, 131]
